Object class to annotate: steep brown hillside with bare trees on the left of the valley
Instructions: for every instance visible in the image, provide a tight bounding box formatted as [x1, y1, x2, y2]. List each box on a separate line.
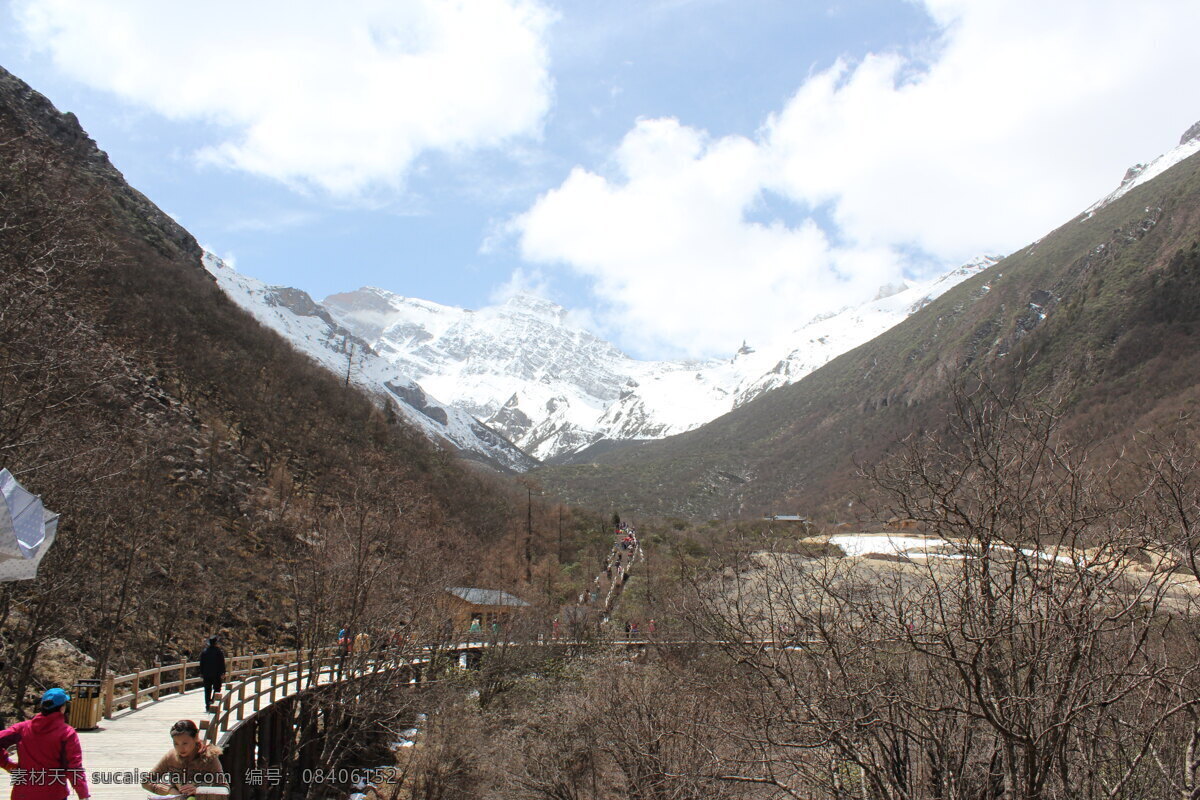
[0, 65, 585, 706]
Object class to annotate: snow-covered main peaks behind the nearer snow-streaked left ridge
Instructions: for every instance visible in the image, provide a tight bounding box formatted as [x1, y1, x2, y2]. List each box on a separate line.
[324, 258, 995, 459]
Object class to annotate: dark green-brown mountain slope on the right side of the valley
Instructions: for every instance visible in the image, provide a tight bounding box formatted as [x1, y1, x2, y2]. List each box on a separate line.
[536, 122, 1200, 522]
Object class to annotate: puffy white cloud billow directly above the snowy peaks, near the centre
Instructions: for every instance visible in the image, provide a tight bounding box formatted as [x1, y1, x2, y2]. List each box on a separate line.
[516, 120, 892, 353]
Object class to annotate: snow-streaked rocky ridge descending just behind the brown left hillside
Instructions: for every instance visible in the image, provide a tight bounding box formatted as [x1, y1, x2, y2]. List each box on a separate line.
[204, 252, 536, 471]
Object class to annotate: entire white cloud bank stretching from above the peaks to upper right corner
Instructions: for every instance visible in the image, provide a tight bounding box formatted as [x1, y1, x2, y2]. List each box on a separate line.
[512, 0, 1200, 354]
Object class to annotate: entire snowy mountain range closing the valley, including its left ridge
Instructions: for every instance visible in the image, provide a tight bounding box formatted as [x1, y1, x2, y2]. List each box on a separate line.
[205, 250, 997, 469]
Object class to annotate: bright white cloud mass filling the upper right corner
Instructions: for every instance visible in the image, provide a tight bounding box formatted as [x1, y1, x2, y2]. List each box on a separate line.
[763, 0, 1200, 259]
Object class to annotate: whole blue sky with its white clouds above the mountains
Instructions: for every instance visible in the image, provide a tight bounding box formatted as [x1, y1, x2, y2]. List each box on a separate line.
[0, 0, 1200, 357]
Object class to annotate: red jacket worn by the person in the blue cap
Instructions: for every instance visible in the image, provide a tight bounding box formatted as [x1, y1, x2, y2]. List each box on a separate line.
[0, 711, 91, 800]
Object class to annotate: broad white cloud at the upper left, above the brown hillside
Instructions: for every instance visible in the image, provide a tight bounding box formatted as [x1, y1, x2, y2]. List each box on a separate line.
[14, 0, 553, 197]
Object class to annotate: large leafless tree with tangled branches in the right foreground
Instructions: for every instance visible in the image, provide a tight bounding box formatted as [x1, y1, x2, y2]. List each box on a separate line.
[695, 387, 1198, 800]
